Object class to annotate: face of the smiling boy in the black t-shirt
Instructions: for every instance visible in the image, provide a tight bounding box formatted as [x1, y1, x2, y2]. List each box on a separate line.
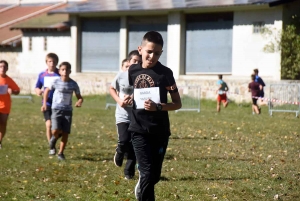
[138, 41, 162, 68]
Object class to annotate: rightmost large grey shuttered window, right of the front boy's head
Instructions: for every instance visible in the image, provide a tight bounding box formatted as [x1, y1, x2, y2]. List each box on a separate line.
[186, 13, 233, 74]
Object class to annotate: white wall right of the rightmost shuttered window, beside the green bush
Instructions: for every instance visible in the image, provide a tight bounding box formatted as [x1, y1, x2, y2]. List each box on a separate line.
[232, 7, 282, 80]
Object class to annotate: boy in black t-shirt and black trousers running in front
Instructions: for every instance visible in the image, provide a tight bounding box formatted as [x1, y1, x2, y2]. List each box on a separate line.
[128, 31, 181, 201]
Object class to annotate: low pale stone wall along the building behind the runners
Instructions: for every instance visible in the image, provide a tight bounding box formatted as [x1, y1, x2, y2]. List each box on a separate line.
[12, 73, 300, 103]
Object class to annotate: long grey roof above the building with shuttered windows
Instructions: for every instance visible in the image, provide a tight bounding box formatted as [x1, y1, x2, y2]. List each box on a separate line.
[50, 0, 296, 14]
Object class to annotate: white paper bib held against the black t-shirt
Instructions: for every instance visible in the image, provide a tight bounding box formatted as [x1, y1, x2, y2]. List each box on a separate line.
[134, 87, 160, 109]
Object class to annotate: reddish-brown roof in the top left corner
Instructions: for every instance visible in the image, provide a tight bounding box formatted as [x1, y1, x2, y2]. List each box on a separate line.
[0, 3, 67, 46]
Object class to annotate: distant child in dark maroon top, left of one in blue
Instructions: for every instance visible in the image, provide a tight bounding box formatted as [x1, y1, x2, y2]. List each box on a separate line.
[248, 74, 263, 114]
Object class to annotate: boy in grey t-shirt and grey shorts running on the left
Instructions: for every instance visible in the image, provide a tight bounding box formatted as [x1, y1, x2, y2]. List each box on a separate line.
[41, 62, 83, 160]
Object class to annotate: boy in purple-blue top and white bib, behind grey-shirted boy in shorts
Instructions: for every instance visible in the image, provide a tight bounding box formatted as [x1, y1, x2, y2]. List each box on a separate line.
[35, 53, 59, 150]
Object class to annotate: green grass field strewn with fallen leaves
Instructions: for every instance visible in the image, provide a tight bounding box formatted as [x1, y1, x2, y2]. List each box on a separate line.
[0, 96, 300, 201]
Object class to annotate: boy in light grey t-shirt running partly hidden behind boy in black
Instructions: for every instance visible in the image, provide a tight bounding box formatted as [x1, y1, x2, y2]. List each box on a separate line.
[109, 50, 142, 179]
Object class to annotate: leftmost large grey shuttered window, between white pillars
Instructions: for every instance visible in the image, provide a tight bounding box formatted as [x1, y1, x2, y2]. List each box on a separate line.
[81, 19, 120, 72]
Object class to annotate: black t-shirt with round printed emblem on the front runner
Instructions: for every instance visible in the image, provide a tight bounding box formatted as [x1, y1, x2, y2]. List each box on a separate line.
[128, 62, 178, 135]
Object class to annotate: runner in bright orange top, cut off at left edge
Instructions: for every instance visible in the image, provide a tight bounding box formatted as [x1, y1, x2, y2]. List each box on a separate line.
[0, 60, 20, 149]
